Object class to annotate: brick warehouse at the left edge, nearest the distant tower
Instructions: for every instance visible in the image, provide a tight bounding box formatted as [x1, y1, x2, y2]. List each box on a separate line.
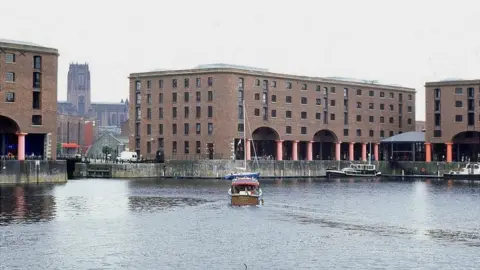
[0, 40, 59, 160]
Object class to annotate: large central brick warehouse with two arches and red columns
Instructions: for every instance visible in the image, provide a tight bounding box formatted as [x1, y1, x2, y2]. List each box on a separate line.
[129, 64, 415, 160]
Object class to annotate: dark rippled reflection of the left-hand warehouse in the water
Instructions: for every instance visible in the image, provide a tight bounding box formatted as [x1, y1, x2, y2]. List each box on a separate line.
[0, 186, 56, 226]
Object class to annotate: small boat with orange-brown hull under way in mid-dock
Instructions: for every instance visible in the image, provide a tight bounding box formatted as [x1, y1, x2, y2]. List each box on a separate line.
[228, 177, 263, 206]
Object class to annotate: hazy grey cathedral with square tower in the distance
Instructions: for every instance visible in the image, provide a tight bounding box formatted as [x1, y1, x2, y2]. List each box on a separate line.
[58, 64, 129, 127]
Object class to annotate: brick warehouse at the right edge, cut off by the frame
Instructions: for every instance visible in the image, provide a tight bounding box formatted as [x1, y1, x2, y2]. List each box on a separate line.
[425, 80, 480, 162]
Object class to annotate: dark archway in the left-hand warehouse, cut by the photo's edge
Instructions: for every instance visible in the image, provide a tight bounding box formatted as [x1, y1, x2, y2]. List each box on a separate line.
[0, 115, 20, 158]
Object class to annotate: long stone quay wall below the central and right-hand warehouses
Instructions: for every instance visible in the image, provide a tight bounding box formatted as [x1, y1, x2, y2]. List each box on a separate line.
[75, 160, 465, 178]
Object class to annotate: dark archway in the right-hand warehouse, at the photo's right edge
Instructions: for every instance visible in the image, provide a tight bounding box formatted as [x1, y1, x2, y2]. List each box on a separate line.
[452, 131, 480, 161]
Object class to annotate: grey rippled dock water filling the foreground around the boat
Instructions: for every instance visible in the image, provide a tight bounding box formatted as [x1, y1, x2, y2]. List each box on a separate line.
[0, 180, 480, 269]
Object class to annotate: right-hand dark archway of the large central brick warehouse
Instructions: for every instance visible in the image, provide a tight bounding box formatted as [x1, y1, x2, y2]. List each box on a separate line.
[312, 129, 338, 160]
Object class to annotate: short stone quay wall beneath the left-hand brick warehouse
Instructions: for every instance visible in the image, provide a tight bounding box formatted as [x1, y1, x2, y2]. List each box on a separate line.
[0, 160, 67, 184]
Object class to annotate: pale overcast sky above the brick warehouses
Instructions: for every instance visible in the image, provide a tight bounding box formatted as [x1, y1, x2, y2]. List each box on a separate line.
[0, 0, 480, 120]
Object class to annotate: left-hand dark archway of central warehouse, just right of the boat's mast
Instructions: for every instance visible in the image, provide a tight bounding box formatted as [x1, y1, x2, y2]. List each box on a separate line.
[251, 127, 280, 160]
